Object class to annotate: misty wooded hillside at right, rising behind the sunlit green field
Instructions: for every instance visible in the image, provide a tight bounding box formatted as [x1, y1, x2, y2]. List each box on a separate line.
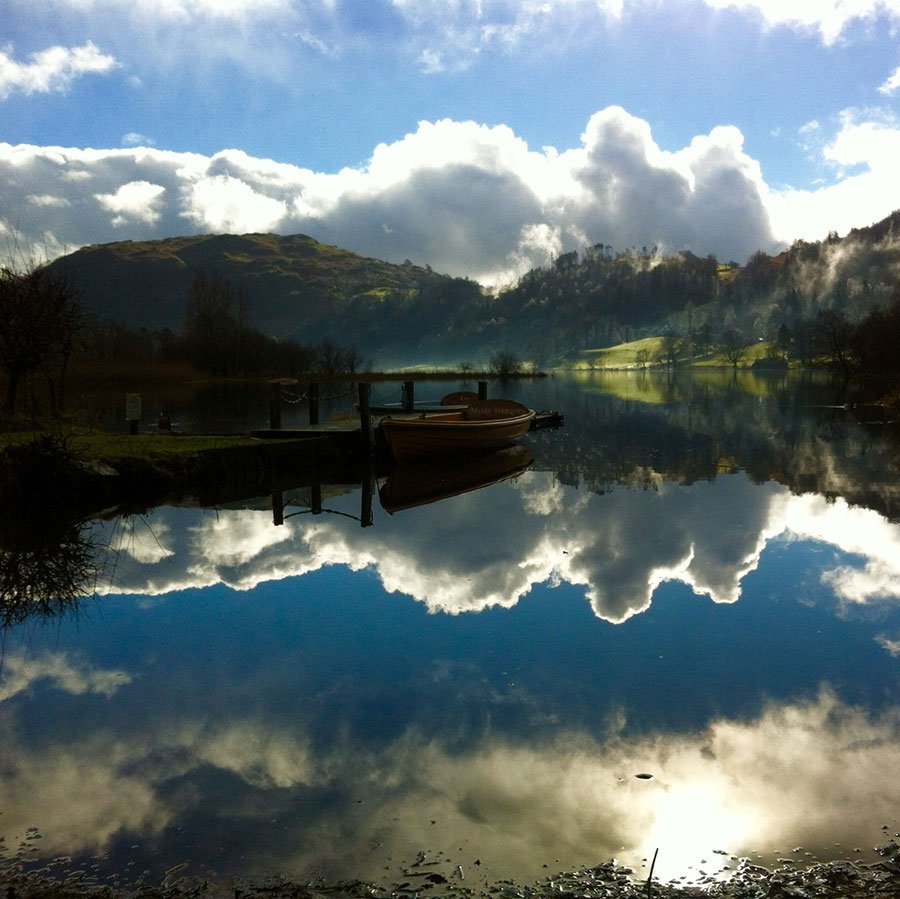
[488, 212, 900, 359]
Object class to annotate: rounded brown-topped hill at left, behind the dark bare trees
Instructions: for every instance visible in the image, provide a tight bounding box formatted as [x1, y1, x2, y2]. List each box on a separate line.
[51, 234, 481, 366]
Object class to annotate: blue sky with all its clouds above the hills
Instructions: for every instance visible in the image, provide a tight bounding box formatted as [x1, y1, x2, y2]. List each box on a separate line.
[0, 0, 900, 286]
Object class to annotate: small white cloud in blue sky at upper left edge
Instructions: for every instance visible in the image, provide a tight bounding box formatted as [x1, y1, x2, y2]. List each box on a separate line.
[0, 41, 118, 100]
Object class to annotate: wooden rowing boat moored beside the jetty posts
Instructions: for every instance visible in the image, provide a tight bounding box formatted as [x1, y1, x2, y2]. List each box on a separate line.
[379, 400, 534, 461]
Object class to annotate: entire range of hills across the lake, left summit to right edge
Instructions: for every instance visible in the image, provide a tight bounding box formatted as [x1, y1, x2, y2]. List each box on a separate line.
[51, 211, 900, 366]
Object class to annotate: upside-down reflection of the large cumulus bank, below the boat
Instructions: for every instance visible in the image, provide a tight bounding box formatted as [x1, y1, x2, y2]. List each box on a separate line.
[93, 460, 900, 623]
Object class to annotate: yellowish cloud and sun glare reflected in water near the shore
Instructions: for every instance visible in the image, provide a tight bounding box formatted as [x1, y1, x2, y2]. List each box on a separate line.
[2, 691, 900, 879]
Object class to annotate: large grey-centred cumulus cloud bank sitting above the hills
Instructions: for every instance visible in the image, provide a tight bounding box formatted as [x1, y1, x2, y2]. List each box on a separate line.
[0, 107, 772, 282]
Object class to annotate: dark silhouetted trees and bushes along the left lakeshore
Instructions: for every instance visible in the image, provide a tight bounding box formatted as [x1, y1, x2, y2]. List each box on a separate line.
[0, 265, 367, 416]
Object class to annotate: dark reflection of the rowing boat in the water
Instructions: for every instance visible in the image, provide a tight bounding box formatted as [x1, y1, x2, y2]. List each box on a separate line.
[378, 445, 532, 514]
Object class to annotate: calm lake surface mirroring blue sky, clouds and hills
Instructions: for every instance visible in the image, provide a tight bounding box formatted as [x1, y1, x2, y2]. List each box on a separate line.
[0, 376, 900, 886]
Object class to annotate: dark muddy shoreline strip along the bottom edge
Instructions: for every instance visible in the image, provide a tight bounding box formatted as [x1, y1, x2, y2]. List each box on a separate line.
[0, 839, 900, 899]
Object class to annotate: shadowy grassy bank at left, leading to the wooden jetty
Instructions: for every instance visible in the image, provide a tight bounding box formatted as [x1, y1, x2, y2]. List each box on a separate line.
[0, 427, 361, 531]
